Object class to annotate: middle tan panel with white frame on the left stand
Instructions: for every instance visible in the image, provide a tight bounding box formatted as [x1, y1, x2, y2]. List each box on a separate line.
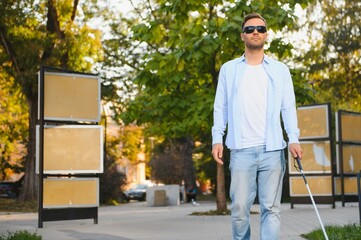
[37, 125, 103, 174]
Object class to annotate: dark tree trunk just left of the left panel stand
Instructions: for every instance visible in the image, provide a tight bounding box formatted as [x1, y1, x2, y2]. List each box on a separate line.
[18, 94, 38, 201]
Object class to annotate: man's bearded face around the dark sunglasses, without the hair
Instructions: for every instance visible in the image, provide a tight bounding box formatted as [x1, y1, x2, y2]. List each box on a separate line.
[241, 18, 267, 50]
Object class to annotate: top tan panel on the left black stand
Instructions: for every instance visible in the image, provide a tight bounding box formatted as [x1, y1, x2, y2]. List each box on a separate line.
[44, 72, 100, 122]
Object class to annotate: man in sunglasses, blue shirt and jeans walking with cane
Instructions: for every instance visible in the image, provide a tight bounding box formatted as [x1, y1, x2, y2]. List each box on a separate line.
[212, 13, 302, 240]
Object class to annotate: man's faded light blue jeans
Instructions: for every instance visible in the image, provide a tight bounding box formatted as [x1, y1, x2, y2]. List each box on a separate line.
[229, 146, 286, 240]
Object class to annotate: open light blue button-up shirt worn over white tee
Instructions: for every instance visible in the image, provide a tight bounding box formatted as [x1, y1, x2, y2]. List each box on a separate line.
[212, 55, 299, 151]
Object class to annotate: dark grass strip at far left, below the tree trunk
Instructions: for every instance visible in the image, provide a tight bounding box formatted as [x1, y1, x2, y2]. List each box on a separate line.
[0, 198, 38, 213]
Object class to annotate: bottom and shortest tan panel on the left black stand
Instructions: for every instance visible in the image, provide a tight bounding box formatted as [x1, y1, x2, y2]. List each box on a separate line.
[43, 178, 99, 208]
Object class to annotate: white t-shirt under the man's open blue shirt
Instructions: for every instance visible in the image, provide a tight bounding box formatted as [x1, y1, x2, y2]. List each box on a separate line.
[238, 64, 268, 148]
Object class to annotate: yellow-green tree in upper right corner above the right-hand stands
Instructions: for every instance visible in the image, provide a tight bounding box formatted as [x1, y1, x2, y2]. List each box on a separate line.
[299, 0, 361, 111]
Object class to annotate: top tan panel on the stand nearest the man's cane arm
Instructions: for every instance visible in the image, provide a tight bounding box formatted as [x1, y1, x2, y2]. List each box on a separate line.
[297, 105, 330, 139]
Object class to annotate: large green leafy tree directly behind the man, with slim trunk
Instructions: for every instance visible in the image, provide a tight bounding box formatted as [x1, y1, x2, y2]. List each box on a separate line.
[107, 0, 308, 210]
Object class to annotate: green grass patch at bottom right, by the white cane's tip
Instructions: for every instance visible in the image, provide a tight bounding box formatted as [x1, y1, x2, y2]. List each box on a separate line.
[302, 224, 361, 240]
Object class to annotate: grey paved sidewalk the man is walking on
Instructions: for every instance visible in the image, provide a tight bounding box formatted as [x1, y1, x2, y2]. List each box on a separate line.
[0, 202, 359, 240]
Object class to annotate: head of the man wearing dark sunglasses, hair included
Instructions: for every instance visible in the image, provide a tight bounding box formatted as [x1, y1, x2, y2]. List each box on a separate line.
[241, 13, 267, 50]
